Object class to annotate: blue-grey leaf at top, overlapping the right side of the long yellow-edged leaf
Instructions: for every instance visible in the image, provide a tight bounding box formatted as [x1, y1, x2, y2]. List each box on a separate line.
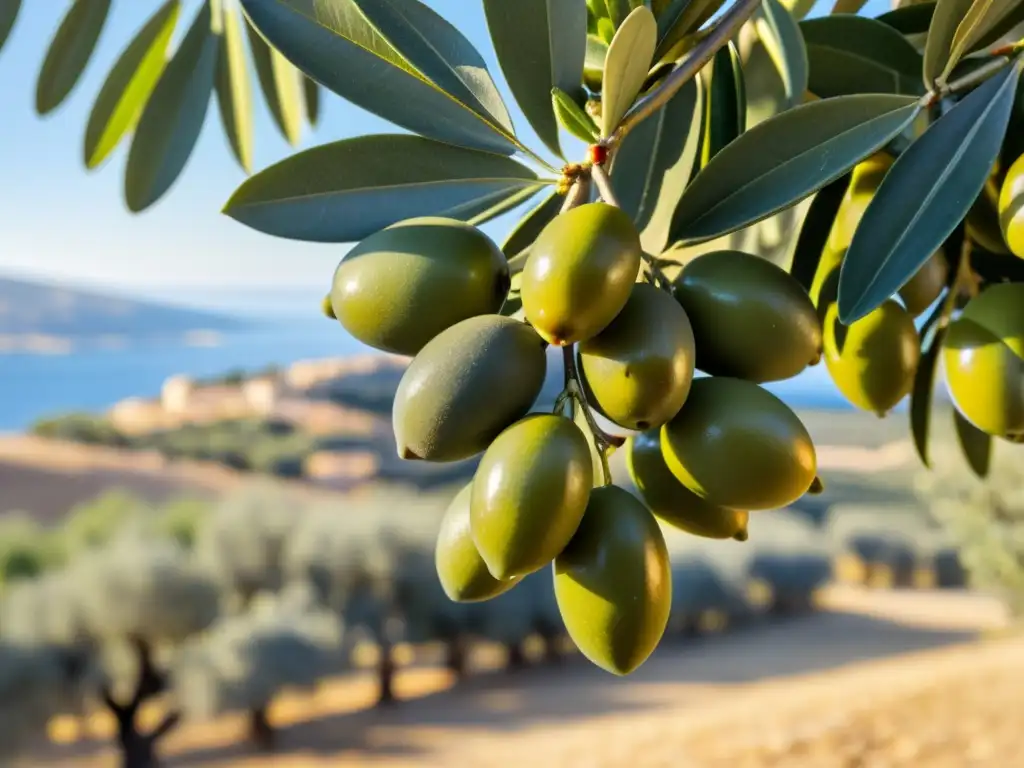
[355, 0, 516, 135]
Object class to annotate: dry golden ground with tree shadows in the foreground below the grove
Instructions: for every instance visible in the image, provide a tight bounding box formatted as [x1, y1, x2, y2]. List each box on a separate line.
[32, 589, 1024, 768]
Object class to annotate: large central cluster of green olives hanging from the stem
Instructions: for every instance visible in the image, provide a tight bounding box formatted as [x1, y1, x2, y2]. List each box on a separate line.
[329, 202, 822, 674]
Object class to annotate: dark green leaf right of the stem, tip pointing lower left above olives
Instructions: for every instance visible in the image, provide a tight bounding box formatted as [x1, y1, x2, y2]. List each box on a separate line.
[672, 94, 921, 243]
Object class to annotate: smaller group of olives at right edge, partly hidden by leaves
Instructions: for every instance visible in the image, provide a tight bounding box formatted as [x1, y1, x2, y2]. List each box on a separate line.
[811, 153, 1024, 440]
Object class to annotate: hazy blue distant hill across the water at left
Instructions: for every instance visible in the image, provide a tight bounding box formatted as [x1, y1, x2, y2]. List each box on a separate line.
[0, 278, 247, 342]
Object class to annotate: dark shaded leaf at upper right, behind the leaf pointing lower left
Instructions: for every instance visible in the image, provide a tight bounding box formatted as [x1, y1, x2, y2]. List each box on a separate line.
[800, 15, 924, 97]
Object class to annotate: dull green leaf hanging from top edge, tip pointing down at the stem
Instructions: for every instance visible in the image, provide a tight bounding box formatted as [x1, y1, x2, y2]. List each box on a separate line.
[483, 0, 587, 157]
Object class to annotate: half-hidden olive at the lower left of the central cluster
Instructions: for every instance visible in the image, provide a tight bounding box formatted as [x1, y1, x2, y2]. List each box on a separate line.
[434, 483, 520, 603]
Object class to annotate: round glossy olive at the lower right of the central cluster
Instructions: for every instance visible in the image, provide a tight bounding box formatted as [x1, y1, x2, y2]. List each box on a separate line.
[662, 376, 817, 511]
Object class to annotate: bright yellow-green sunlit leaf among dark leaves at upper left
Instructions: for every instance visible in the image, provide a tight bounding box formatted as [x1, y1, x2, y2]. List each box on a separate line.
[84, 0, 181, 168]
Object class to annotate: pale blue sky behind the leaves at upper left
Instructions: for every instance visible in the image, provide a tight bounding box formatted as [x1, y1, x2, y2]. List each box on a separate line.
[0, 0, 889, 296]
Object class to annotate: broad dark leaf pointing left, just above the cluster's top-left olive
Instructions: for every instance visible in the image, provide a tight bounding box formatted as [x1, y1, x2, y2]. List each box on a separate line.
[224, 134, 540, 243]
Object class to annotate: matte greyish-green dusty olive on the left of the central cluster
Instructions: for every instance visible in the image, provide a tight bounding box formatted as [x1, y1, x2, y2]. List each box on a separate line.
[391, 314, 547, 462]
